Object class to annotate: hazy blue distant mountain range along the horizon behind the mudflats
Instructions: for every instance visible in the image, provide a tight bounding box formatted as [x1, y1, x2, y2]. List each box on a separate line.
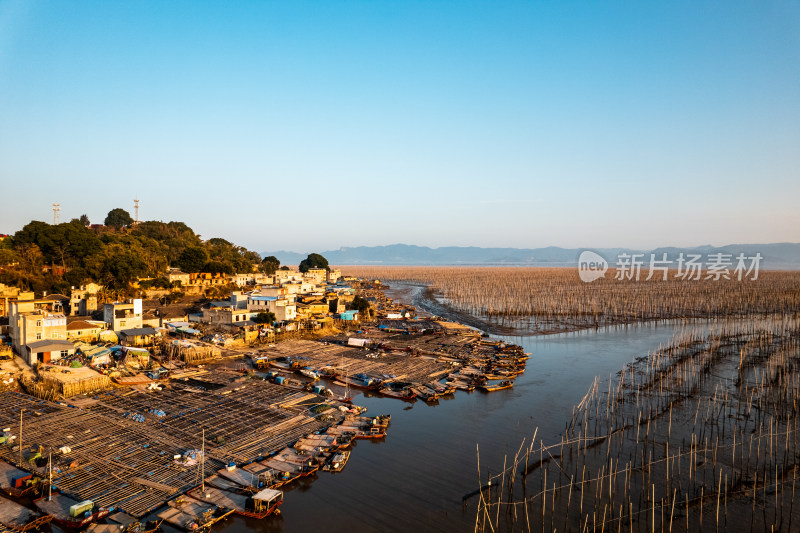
[261, 243, 800, 270]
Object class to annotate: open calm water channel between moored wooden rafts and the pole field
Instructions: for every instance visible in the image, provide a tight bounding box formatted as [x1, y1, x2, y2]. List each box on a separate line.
[211, 316, 708, 533]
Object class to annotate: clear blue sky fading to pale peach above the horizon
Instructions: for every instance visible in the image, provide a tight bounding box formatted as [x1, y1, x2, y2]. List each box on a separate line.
[0, 0, 800, 252]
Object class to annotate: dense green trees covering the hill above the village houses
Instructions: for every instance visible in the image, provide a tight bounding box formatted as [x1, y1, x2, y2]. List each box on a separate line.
[0, 209, 268, 293]
